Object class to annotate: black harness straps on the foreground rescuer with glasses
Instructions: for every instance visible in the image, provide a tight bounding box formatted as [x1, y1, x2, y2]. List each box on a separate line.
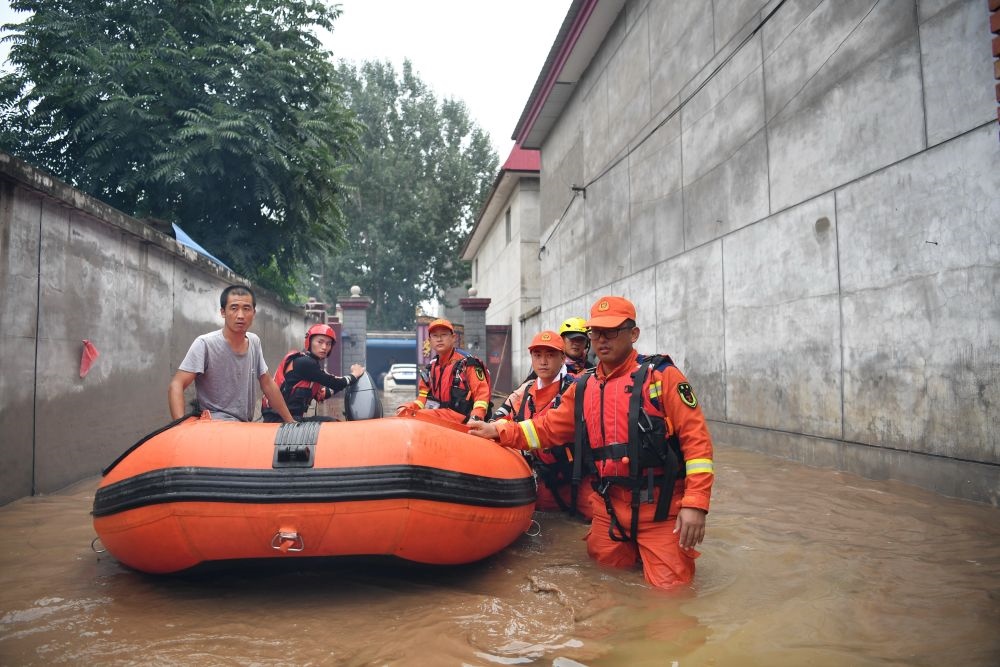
[573, 355, 685, 542]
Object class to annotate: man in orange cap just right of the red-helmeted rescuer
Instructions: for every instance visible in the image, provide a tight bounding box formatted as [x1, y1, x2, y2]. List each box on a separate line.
[396, 319, 490, 423]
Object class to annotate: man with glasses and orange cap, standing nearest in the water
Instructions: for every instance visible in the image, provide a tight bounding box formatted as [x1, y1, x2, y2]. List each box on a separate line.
[469, 296, 715, 588]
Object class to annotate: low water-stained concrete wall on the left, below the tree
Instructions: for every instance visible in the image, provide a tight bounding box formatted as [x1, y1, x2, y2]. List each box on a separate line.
[0, 153, 305, 503]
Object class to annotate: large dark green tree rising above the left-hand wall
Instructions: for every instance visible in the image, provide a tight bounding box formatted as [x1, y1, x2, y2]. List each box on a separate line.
[0, 0, 359, 296]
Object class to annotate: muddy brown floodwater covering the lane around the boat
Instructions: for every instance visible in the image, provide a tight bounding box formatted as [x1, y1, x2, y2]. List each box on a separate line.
[0, 388, 1000, 667]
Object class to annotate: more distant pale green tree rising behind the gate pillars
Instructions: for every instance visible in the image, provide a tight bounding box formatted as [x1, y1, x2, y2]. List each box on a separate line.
[324, 61, 498, 329]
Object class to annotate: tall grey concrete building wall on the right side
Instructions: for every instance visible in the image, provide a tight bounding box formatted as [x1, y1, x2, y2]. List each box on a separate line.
[536, 0, 1000, 504]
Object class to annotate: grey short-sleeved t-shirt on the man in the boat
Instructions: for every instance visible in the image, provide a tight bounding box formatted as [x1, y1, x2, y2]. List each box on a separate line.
[180, 329, 267, 421]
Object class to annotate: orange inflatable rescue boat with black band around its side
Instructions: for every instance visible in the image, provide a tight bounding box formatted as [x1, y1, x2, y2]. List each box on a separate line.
[93, 417, 535, 573]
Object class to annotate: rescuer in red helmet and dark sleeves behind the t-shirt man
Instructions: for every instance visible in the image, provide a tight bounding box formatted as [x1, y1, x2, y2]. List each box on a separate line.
[261, 324, 365, 422]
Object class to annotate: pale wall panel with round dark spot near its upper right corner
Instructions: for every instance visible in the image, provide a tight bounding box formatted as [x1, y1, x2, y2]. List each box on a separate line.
[723, 195, 841, 437]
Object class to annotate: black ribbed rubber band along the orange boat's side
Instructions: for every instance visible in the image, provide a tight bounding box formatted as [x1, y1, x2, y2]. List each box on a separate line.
[93, 465, 535, 517]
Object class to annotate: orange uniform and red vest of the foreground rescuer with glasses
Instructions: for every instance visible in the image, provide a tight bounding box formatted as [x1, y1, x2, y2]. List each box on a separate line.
[496, 350, 715, 588]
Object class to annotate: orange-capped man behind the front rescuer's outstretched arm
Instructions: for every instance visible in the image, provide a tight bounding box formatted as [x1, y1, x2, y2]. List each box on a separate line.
[492, 332, 594, 520]
